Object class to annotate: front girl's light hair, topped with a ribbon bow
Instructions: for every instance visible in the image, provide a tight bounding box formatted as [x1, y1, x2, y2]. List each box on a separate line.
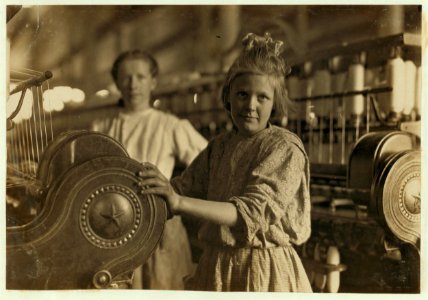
[221, 33, 291, 119]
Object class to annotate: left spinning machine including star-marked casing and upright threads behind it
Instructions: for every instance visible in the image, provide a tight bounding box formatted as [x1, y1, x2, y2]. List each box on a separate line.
[6, 70, 167, 289]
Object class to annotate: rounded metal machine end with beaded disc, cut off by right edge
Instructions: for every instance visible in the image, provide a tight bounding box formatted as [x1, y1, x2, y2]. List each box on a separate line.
[348, 131, 421, 245]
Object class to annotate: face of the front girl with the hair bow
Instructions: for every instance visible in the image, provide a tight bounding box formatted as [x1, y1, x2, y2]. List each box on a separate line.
[229, 74, 274, 136]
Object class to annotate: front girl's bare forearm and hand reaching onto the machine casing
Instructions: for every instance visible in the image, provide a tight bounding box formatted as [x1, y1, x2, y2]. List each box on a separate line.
[138, 163, 238, 226]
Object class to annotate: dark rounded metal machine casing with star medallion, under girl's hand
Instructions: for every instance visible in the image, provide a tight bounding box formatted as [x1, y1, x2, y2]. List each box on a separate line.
[6, 131, 167, 289]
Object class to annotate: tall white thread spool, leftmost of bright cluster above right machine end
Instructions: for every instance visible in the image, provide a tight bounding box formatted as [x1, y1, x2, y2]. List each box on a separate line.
[386, 47, 406, 122]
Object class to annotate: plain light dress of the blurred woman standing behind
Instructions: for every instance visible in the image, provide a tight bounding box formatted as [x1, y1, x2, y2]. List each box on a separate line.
[92, 108, 207, 290]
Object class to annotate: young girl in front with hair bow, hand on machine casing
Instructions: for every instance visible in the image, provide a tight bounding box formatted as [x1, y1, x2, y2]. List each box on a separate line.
[139, 34, 311, 292]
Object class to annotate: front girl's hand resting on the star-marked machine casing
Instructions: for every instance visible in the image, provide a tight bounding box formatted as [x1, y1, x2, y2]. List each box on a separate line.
[137, 162, 180, 214]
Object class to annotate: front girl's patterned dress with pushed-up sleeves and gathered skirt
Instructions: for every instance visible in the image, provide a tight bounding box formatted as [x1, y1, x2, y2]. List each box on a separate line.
[172, 125, 311, 292]
